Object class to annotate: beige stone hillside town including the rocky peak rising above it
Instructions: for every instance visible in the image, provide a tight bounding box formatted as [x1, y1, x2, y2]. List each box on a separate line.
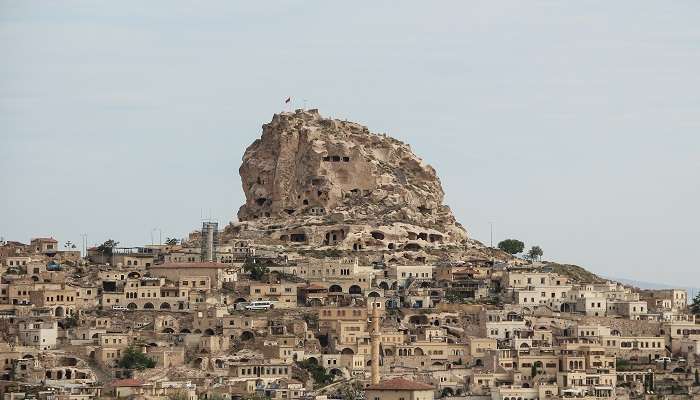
[0, 110, 700, 400]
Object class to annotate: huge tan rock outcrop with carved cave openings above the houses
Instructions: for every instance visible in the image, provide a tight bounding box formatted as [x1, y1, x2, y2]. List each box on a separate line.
[236, 110, 467, 251]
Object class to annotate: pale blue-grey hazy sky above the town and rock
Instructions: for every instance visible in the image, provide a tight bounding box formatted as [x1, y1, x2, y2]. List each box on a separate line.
[0, 0, 700, 286]
